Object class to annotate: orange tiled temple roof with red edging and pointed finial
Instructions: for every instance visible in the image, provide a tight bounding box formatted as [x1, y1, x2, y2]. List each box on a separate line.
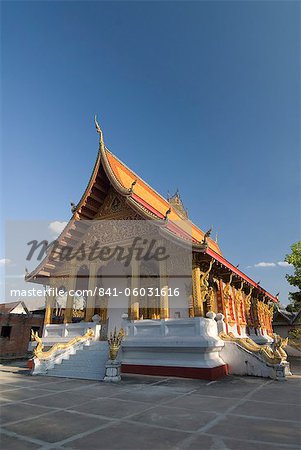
[26, 120, 278, 302]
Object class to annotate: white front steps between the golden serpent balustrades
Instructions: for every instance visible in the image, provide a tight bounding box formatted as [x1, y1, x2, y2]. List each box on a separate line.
[47, 341, 109, 380]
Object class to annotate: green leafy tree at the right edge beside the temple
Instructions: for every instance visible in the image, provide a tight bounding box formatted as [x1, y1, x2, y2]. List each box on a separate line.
[284, 241, 301, 311]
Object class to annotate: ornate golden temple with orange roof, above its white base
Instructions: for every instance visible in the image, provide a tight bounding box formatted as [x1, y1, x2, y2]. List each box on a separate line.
[26, 120, 286, 380]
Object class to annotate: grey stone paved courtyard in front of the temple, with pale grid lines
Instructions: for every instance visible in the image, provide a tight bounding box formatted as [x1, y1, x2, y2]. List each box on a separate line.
[0, 366, 301, 450]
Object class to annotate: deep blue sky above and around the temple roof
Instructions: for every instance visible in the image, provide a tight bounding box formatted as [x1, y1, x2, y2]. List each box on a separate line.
[0, 2, 300, 303]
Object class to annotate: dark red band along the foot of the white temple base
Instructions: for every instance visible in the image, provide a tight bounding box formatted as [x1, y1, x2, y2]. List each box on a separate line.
[121, 364, 228, 380]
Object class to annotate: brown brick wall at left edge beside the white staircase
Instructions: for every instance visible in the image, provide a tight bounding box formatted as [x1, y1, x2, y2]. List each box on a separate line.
[0, 313, 44, 358]
